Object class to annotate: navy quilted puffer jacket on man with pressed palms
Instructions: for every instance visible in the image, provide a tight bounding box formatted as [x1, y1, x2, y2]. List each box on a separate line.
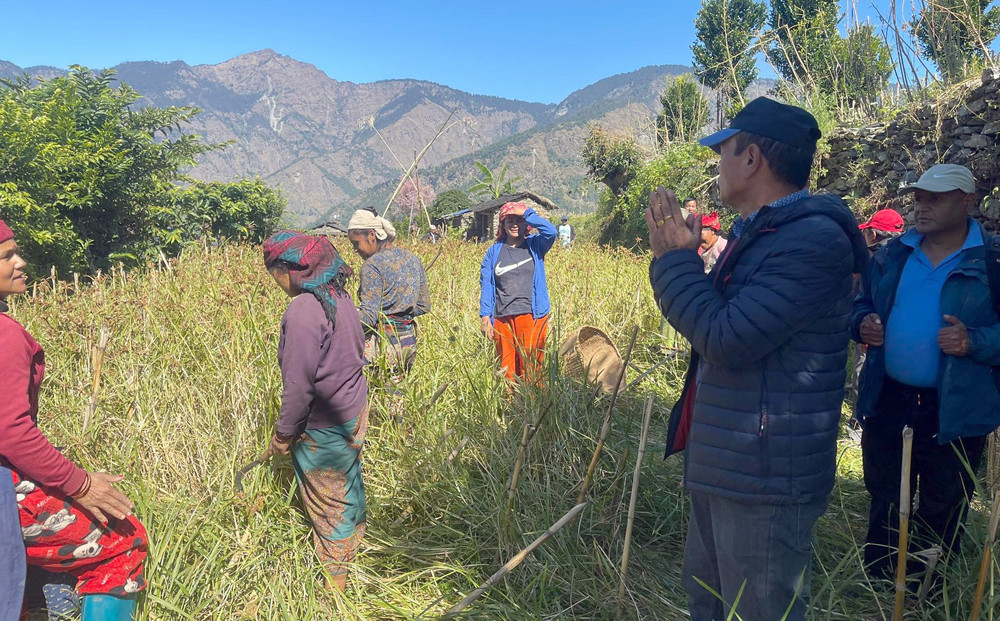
[650, 195, 868, 504]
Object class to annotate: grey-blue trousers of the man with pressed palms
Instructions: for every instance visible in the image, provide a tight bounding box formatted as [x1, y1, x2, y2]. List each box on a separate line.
[683, 492, 827, 621]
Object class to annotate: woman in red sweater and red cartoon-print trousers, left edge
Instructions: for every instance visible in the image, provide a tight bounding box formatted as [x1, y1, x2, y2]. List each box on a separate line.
[0, 220, 146, 621]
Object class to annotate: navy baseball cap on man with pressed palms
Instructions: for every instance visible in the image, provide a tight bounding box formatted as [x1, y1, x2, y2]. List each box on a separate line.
[698, 97, 823, 152]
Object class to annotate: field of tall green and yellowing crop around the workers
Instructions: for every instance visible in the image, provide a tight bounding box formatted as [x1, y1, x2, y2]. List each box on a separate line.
[12, 242, 996, 621]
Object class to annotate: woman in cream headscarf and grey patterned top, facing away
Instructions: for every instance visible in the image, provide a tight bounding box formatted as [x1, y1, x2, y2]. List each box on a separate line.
[347, 208, 431, 380]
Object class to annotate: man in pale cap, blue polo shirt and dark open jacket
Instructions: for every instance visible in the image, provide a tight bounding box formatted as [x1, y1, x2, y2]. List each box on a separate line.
[852, 164, 1000, 577]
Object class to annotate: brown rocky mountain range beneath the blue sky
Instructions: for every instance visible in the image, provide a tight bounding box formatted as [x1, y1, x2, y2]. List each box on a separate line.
[0, 50, 691, 226]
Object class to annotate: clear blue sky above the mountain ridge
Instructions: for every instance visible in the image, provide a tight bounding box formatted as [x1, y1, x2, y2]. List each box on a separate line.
[0, 0, 940, 103]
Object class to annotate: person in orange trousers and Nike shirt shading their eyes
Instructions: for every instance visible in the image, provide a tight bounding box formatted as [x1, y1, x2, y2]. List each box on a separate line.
[479, 203, 557, 385]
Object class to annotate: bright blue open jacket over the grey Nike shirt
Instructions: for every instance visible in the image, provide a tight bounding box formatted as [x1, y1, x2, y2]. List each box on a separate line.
[479, 209, 557, 319]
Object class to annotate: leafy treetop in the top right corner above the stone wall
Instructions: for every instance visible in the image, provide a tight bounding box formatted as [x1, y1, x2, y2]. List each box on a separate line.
[911, 0, 1000, 82]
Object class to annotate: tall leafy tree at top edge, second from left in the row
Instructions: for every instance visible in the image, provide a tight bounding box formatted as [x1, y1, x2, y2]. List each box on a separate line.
[767, 0, 840, 85]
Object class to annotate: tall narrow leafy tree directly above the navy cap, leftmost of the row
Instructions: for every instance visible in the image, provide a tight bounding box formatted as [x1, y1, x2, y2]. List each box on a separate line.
[691, 0, 767, 124]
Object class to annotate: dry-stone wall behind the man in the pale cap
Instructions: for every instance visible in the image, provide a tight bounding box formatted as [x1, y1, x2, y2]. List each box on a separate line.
[816, 69, 1000, 230]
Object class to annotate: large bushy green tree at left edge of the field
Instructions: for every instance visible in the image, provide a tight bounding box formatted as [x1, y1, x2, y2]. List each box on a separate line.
[0, 67, 284, 275]
